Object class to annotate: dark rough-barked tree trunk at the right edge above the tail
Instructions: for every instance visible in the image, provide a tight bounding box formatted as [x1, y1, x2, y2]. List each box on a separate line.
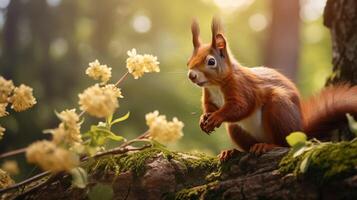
[324, 0, 357, 85]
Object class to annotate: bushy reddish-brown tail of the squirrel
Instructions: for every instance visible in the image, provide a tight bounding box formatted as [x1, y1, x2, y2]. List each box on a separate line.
[302, 84, 357, 137]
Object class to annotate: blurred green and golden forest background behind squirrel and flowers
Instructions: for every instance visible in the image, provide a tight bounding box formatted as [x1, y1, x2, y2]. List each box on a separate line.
[0, 0, 331, 179]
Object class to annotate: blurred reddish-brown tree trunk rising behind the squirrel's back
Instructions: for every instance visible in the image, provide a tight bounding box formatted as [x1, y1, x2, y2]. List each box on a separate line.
[264, 0, 300, 81]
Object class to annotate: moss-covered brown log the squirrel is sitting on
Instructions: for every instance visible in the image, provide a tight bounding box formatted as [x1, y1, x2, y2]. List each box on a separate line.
[3, 141, 357, 199]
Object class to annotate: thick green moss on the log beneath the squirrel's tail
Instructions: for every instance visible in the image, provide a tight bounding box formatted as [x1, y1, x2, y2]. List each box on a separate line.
[279, 140, 357, 183]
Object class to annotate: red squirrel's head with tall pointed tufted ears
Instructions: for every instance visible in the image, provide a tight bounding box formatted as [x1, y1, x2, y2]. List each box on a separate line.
[187, 18, 234, 87]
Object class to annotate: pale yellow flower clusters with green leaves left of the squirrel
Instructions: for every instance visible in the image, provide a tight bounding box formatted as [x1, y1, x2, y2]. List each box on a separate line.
[0, 49, 183, 192]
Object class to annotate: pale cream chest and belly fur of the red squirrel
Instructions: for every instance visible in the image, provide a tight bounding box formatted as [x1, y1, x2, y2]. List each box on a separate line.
[207, 86, 268, 142]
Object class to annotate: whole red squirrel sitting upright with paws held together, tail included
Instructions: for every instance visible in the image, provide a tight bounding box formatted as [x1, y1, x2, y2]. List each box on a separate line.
[187, 18, 357, 160]
